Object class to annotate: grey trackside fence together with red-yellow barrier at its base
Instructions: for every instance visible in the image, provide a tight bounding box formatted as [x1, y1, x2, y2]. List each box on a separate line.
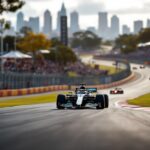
[0, 60, 133, 97]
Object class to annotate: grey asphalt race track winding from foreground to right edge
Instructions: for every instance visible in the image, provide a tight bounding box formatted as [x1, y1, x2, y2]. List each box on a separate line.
[0, 60, 150, 150]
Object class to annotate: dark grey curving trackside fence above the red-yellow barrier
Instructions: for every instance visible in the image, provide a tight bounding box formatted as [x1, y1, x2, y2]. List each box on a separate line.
[0, 60, 131, 90]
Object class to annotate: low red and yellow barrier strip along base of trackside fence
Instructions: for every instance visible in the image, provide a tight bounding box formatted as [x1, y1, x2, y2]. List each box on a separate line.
[0, 73, 135, 97]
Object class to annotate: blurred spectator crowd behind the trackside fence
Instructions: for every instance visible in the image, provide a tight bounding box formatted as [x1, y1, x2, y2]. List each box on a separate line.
[4, 59, 107, 76]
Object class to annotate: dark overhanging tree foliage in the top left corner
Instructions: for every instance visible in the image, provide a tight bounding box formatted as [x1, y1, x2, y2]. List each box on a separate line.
[0, 0, 24, 14]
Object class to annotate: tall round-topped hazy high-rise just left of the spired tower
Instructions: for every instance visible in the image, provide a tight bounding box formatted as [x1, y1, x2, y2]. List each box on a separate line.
[43, 10, 52, 38]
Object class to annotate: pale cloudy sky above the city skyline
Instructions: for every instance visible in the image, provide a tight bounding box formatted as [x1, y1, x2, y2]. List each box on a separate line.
[1, 0, 150, 29]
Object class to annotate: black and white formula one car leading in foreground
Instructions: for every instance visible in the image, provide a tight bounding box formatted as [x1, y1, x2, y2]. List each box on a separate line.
[56, 84, 109, 109]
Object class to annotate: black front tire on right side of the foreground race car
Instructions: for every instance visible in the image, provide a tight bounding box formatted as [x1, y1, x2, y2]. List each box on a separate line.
[95, 95, 105, 109]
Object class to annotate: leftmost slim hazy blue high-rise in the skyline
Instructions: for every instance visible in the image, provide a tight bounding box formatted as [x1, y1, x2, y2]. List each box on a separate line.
[16, 12, 24, 32]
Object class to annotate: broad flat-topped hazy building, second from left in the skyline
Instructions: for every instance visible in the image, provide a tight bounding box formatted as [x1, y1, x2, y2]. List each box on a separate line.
[29, 17, 40, 33]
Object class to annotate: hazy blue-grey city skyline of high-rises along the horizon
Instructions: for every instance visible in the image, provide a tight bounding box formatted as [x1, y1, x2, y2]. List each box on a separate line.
[6, 8, 150, 40]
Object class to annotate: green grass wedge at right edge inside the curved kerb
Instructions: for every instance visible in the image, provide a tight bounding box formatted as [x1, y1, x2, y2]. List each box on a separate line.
[128, 93, 150, 107]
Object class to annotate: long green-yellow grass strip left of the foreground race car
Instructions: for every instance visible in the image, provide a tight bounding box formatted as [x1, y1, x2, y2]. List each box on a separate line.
[0, 92, 67, 108]
